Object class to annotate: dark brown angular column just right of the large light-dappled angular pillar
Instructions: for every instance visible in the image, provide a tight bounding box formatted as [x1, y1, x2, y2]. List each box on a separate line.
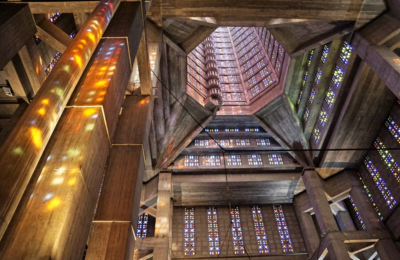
[86, 96, 151, 260]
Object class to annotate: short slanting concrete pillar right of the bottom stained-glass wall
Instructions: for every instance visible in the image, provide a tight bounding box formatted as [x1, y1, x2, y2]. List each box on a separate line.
[303, 170, 339, 234]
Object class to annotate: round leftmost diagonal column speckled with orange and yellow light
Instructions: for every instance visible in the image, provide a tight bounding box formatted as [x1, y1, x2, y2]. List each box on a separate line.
[0, 0, 120, 242]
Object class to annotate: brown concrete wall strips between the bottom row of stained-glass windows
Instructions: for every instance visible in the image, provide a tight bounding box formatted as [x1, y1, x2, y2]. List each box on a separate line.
[171, 204, 306, 259]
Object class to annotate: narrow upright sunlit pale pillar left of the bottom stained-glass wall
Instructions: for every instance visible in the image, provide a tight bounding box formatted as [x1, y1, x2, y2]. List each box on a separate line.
[153, 172, 173, 260]
